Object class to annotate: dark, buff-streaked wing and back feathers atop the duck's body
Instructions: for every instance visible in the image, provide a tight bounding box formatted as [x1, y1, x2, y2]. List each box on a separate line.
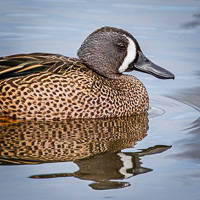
[0, 53, 77, 79]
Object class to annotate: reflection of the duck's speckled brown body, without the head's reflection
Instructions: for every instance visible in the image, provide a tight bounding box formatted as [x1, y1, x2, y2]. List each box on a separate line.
[0, 113, 148, 164]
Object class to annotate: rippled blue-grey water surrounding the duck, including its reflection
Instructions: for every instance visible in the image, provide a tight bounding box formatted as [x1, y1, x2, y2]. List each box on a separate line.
[0, 0, 200, 200]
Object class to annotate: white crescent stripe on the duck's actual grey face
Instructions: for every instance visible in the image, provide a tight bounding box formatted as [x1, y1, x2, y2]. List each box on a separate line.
[119, 35, 136, 73]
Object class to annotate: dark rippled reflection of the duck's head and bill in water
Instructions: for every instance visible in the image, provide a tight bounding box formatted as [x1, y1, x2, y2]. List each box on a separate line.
[31, 145, 171, 190]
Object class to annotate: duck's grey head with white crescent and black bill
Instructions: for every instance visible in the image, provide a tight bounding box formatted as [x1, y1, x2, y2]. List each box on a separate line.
[78, 27, 174, 79]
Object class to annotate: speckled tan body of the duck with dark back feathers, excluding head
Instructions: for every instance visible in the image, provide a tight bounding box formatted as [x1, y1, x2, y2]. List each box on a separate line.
[0, 26, 173, 120]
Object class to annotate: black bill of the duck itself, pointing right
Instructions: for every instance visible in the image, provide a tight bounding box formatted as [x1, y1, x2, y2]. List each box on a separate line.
[127, 51, 175, 79]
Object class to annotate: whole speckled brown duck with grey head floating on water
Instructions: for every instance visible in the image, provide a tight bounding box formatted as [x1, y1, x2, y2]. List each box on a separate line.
[0, 26, 175, 121]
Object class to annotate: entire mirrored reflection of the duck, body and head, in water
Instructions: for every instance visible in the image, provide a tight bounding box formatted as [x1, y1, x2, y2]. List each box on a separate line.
[0, 113, 169, 189]
